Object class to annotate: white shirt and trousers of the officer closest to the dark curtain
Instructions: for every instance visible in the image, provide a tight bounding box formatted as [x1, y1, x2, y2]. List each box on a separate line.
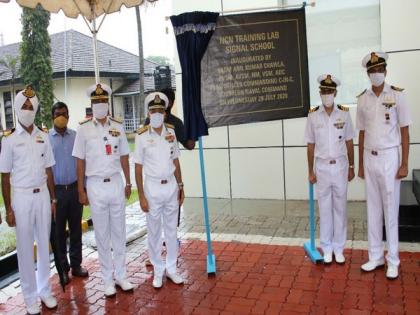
[134, 126, 179, 276]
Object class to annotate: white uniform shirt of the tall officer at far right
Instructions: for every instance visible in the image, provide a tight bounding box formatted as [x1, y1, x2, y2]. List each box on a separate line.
[356, 83, 412, 150]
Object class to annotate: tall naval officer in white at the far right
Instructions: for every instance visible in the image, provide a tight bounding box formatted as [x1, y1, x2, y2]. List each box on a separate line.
[356, 52, 412, 279]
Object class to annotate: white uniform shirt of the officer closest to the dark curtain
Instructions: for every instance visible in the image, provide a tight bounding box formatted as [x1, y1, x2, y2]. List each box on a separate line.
[134, 126, 180, 179]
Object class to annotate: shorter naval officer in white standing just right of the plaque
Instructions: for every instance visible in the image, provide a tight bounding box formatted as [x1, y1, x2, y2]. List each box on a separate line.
[305, 74, 355, 264]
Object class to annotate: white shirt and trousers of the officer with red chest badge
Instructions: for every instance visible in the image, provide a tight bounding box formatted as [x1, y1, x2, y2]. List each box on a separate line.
[73, 117, 129, 285]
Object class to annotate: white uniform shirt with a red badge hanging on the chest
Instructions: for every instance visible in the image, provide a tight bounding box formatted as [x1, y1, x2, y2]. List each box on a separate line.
[73, 117, 130, 178]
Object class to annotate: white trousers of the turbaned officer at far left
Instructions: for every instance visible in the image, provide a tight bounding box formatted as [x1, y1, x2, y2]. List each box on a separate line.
[12, 184, 51, 306]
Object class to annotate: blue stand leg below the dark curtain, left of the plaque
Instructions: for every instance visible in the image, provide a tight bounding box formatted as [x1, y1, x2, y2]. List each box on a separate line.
[198, 137, 216, 273]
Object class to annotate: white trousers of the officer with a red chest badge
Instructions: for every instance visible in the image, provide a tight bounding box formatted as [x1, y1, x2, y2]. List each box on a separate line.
[86, 174, 126, 284]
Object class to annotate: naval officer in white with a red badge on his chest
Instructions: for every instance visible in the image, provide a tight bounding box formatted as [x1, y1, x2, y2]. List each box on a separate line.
[73, 84, 133, 297]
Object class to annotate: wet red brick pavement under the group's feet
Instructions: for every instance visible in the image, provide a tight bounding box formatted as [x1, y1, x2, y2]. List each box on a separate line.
[0, 241, 420, 315]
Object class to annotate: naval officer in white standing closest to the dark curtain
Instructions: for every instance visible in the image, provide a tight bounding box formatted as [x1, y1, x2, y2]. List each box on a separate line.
[134, 92, 184, 288]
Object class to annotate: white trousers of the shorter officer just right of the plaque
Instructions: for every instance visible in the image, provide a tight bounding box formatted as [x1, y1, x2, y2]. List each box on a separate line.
[315, 156, 349, 254]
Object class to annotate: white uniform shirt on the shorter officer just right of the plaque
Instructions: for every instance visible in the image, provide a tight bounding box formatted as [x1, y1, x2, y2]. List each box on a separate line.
[305, 104, 354, 159]
